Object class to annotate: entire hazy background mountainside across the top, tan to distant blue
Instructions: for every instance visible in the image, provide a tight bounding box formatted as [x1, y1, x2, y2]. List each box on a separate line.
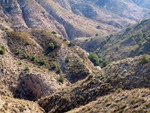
[0, 0, 150, 39]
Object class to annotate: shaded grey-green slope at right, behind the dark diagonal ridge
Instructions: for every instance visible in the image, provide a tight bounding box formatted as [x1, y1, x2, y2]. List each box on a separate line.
[74, 19, 150, 61]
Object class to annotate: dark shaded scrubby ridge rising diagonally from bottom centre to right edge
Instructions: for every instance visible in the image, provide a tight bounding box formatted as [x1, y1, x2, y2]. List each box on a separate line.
[39, 54, 150, 113]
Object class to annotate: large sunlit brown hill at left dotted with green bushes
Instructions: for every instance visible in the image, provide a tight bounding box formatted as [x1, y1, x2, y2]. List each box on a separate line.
[0, 17, 98, 100]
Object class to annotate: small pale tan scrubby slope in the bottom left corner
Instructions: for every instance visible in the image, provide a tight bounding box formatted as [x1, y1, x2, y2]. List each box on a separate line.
[0, 96, 45, 113]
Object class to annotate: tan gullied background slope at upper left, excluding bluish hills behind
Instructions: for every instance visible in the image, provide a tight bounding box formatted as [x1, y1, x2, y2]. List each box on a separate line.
[0, 0, 121, 39]
